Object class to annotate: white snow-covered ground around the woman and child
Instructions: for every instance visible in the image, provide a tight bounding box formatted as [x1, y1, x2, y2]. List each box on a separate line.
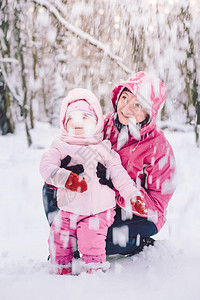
[0, 123, 200, 300]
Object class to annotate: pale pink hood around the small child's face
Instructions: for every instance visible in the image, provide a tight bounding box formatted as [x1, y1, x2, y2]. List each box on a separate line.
[60, 88, 104, 145]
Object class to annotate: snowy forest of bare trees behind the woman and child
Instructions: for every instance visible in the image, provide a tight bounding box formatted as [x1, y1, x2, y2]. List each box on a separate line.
[0, 0, 200, 146]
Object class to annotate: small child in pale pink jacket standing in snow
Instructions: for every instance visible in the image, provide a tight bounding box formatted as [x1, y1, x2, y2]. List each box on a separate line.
[40, 89, 147, 274]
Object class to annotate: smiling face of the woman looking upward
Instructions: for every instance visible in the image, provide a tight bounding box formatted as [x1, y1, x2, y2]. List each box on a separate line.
[117, 91, 147, 125]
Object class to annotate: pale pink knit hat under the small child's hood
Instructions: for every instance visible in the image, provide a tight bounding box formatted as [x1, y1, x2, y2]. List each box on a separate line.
[63, 99, 97, 125]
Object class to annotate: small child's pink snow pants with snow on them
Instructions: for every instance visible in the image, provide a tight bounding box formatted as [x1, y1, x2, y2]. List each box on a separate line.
[49, 208, 115, 265]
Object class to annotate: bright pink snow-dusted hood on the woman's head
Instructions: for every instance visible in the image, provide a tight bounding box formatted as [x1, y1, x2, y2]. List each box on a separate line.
[112, 72, 166, 134]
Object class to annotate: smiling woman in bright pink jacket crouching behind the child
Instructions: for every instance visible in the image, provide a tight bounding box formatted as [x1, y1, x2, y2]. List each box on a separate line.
[43, 72, 175, 255]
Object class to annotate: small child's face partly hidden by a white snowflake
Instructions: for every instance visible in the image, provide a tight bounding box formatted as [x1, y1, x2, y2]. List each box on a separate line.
[66, 111, 96, 135]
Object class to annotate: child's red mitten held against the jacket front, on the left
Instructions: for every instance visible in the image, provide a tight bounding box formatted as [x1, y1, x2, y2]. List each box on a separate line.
[65, 172, 87, 193]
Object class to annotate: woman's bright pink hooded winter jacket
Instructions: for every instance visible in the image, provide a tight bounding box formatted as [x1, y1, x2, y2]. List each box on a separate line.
[104, 72, 175, 231]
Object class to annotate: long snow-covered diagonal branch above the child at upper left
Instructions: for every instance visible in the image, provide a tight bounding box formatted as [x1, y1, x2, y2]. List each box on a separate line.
[32, 0, 132, 74]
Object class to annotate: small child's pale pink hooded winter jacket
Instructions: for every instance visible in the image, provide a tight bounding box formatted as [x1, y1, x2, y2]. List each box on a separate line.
[40, 89, 141, 216]
